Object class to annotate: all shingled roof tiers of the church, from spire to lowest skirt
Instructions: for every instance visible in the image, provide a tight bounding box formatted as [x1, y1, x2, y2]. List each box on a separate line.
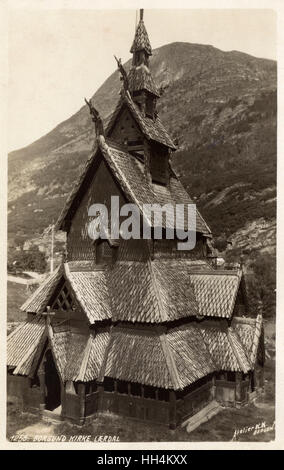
[8, 10, 262, 396]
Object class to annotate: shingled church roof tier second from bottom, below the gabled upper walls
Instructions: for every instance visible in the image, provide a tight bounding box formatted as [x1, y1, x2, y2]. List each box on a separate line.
[19, 259, 241, 324]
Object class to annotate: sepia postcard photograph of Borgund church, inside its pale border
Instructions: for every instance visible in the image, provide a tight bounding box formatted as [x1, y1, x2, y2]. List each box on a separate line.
[1, 1, 283, 449]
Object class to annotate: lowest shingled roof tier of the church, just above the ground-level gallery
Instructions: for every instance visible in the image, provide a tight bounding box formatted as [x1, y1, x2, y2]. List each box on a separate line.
[8, 316, 262, 390]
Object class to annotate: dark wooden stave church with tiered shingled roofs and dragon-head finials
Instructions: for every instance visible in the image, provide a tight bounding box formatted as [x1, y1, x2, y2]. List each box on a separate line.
[7, 10, 264, 429]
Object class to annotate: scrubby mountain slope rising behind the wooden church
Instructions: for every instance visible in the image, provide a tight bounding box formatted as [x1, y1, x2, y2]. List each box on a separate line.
[9, 43, 276, 262]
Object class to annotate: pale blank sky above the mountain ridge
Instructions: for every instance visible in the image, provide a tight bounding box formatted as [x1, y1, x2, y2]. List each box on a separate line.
[8, 9, 276, 151]
